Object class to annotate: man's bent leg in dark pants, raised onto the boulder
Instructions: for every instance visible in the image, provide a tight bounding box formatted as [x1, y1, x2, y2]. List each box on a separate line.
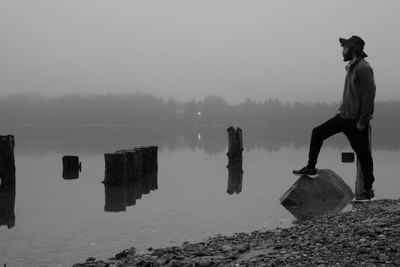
[307, 114, 344, 168]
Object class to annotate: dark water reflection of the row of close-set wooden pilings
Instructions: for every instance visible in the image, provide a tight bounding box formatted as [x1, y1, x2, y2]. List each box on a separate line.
[104, 171, 158, 212]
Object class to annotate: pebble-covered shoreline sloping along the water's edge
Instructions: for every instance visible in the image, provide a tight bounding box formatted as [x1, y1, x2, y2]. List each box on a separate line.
[73, 199, 400, 267]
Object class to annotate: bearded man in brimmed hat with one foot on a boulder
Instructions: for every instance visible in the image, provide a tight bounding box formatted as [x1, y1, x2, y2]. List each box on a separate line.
[293, 35, 376, 201]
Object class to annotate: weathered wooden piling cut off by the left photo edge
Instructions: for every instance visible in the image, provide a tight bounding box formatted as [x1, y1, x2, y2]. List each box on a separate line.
[0, 135, 15, 185]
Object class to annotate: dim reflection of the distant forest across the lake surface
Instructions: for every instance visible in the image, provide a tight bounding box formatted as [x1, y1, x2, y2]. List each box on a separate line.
[5, 125, 400, 155]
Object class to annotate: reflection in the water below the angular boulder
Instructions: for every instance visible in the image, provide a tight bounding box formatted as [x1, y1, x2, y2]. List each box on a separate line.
[283, 197, 352, 221]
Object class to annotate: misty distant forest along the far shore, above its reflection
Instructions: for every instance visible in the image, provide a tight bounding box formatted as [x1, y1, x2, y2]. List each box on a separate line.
[0, 94, 400, 130]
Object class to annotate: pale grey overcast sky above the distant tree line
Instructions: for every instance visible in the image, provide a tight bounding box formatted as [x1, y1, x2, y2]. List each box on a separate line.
[0, 0, 400, 103]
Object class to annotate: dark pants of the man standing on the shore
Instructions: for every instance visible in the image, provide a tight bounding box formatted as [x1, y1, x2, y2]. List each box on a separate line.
[307, 114, 375, 189]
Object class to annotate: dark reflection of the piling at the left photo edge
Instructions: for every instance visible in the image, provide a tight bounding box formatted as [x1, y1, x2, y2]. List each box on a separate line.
[0, 184, 15, 229]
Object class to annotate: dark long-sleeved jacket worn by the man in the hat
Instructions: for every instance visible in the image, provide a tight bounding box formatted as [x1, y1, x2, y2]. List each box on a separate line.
[339, 58, 376, 125]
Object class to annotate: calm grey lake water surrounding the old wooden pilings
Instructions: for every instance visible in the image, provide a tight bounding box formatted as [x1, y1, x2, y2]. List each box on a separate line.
[0, 126, 400, 266]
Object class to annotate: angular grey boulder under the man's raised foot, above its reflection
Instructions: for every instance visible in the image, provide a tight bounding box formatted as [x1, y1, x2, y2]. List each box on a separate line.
[279, 169, 354, 208]
